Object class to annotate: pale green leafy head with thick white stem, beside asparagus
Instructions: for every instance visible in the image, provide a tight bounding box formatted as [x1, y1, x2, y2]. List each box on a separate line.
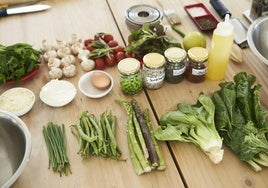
[154, 93, 224, 164]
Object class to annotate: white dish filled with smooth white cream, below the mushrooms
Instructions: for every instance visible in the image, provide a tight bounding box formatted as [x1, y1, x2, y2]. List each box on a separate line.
[39, 79, 76, 107]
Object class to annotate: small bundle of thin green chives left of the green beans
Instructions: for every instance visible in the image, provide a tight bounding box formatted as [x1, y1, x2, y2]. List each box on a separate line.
[43, 122, 72, 176]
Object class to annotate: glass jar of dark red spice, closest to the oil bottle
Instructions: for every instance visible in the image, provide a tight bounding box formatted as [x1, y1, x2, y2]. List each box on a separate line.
[185, 47, 208, 83]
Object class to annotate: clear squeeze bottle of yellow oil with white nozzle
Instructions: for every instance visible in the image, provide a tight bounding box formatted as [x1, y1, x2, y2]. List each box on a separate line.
[206, 14, 234, 81]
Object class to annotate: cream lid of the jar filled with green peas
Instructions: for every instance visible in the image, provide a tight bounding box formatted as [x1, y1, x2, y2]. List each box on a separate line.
[117, 57, 140, 75]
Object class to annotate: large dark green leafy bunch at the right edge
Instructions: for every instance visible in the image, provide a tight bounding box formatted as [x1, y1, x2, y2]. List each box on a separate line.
[212, 72, 268, 171]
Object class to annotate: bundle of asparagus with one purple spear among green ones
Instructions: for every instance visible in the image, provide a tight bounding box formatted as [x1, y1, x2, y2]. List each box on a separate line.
[116, 99, 166, 175]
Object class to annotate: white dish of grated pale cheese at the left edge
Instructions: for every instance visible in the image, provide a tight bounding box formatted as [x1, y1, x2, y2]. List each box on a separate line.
[0, 87, 35, 116]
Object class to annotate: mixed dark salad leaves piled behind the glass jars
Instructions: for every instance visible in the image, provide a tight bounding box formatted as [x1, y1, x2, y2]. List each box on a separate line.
[125, 23, 181, 58]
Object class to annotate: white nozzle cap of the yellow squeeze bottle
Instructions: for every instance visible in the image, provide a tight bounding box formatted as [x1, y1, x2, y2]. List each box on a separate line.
[214, 14, 234, 36]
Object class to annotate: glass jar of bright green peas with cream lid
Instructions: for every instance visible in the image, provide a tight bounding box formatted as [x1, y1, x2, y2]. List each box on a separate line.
[117, 58, 143, 95]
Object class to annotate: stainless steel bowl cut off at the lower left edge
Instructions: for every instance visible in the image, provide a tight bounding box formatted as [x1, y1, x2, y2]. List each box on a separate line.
[0, 110, 31, 188]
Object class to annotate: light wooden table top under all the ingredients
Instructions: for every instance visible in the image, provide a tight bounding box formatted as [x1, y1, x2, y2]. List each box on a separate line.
[0, 0, 268, 188]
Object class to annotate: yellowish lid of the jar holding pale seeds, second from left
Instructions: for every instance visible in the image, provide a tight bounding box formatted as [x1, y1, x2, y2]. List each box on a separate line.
[143, 52, 165, 68]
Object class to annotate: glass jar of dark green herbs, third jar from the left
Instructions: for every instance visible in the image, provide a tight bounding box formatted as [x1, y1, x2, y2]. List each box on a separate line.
[164, 47, 187, 83]
